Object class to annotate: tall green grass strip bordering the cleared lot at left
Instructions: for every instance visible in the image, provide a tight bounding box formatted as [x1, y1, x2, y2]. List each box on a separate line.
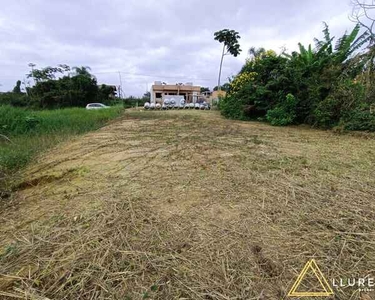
[0, 106, 123, 175]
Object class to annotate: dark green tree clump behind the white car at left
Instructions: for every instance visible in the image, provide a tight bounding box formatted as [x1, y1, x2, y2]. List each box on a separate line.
[0, 65, 119, 109]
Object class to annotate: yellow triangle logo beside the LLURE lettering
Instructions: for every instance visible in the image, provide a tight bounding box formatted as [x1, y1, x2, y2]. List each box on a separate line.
[288, 259, 334, 297]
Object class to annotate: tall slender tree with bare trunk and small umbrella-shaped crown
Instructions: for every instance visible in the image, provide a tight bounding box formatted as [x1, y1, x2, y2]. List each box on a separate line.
[214, 29, 242, 90]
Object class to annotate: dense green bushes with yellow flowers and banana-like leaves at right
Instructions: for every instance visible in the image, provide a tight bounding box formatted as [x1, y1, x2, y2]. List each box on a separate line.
[220, 24, 375, 131]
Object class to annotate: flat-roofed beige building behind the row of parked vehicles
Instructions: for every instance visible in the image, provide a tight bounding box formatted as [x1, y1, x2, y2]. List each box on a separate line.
[150, 81, 201, 104]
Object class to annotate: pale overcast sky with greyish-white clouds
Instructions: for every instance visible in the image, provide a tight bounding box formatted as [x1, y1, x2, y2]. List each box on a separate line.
[0, 0, 354, 95]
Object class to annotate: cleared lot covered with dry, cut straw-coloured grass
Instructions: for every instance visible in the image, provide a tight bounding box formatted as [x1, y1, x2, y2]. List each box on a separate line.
[0, 111, 375, 299]
